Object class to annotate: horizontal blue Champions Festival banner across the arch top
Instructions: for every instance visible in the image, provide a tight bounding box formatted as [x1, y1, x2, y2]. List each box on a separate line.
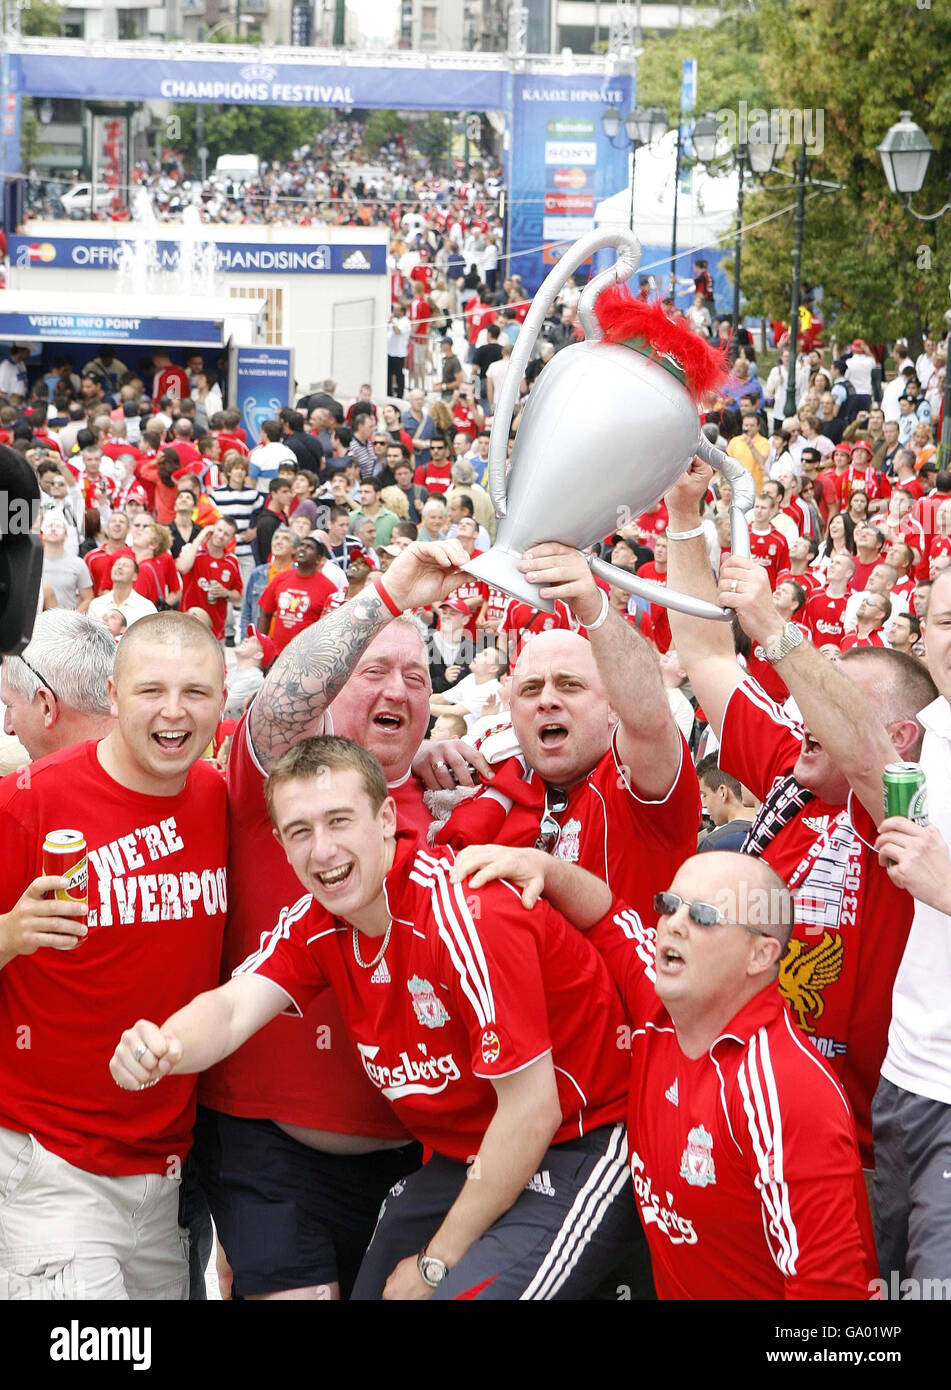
[11, 53, 507, 111]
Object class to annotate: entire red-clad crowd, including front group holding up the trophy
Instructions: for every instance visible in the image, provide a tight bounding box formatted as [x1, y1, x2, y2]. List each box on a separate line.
[0, 279, 951, 1300]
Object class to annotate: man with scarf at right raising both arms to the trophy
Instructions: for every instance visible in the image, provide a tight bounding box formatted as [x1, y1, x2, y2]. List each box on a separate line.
[667, 460, 933, 1168]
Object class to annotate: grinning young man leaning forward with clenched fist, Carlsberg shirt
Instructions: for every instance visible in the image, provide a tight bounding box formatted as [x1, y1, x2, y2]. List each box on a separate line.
[113, 738, 634, 1301]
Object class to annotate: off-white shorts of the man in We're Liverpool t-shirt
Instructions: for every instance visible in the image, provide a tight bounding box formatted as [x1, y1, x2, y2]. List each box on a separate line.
[0, 1129, 188, 1301]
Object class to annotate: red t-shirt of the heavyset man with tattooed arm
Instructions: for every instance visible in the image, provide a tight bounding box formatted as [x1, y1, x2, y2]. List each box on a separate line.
[202, 717, 430, 1138]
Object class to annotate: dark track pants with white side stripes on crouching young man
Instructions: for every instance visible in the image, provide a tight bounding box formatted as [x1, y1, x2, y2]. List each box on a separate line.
[353, 1125, 640, 1301]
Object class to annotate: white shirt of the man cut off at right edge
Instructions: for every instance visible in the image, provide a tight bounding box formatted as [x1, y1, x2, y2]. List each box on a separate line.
[881, 695, 951, 1105]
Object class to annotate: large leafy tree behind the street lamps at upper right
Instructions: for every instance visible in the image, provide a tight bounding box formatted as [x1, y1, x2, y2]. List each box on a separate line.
[742, 0, 951, 342]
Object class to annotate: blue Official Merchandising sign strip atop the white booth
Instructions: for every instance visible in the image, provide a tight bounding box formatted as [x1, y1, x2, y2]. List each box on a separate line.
[10, 236, 387, 275]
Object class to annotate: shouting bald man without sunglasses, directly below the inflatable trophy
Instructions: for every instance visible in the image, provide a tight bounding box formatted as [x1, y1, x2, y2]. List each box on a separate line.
[438, 542, 699, 934]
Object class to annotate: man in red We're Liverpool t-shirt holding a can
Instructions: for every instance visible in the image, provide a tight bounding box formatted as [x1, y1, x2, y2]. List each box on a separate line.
[0, 613, 228, 1300]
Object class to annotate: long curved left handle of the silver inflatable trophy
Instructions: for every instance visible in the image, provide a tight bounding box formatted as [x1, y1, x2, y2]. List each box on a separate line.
[488, 227, 642, 518]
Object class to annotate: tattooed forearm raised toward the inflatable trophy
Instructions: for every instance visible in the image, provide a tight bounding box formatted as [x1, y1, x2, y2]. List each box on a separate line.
[247, 584, 392, 769]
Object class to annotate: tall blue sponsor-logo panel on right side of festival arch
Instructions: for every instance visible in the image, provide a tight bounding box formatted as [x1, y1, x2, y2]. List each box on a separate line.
[507, 74, 634, 293]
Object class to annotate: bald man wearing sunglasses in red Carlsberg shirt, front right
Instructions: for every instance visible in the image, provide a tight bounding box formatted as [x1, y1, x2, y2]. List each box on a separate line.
[453, 845, 876, 1300]
